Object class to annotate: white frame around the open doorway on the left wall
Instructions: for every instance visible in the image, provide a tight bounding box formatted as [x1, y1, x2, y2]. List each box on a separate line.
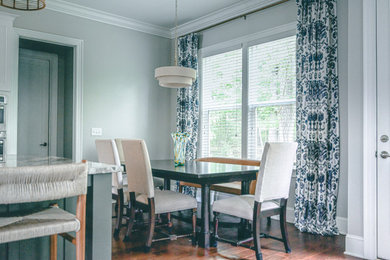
[15, 28, 84, 162]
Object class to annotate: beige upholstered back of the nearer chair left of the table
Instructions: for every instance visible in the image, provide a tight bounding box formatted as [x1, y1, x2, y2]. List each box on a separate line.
[122, 139, 154, 198]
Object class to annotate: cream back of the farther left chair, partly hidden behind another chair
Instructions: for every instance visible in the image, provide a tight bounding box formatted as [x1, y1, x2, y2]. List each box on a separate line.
[95, 139, 123, 189]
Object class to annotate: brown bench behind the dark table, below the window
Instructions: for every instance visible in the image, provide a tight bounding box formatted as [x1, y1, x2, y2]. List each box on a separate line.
[179, 157, 260, 195]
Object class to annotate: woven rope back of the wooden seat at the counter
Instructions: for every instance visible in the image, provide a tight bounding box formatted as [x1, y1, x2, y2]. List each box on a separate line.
[0, 163, 88, 204]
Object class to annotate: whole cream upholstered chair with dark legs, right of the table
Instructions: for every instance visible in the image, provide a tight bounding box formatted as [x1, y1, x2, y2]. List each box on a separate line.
[213, 143, 297, 259]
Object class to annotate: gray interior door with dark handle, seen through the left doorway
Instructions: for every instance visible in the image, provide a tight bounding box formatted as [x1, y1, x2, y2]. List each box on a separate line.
[17, 49, 58, 157]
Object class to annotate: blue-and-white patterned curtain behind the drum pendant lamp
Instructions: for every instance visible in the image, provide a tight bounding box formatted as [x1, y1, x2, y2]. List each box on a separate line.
[176, 33, 199, 160]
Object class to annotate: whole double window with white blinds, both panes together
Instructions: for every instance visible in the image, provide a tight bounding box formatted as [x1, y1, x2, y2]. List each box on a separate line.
[201, 36, 296, 159]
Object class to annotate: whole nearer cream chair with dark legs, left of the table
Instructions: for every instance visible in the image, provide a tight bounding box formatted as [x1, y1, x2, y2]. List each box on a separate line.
[122, 140, 197, 251]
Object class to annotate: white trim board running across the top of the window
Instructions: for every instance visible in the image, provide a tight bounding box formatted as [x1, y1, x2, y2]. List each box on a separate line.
[200, 22, 297, 58]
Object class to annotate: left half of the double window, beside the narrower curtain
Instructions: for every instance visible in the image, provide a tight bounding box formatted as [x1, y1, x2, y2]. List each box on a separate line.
[201, 49, 242, 157]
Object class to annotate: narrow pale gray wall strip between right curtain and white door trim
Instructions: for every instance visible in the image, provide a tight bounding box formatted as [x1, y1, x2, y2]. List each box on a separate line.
[343, 0, 363, 240]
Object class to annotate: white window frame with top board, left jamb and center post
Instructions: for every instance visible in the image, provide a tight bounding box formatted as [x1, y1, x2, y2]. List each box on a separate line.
[198, 22, 297, 158]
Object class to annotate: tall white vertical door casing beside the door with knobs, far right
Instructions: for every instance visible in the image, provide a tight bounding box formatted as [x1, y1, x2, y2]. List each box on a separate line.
[362, 0, 377, 259]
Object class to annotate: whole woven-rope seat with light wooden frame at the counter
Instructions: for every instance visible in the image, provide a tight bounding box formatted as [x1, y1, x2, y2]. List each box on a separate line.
[0, 163, 87, 260]
